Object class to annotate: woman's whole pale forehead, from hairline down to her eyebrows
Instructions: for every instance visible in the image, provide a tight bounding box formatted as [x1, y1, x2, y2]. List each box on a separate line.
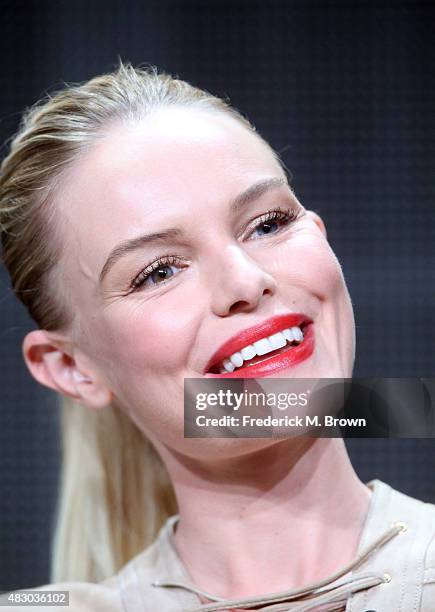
[59, 108, 283, 276]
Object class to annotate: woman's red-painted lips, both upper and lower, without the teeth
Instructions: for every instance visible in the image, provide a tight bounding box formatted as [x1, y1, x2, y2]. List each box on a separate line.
[204, 313, 314, 378]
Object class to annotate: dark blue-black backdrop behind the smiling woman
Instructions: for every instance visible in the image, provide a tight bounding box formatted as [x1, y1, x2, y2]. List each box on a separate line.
[0, 0, 435, 591]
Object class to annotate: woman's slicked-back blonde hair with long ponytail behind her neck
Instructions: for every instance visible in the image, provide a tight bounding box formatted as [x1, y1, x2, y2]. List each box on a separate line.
[0, 61, 281, 582]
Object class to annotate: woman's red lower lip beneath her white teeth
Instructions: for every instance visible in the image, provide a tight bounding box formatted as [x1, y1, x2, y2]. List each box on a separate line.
[206, 323, 314, 378]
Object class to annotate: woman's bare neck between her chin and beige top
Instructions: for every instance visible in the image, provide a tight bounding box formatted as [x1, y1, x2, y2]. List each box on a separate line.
[158, 438, 371, 597]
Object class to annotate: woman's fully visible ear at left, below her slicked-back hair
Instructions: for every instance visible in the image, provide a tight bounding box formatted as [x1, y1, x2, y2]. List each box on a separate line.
[22, 329, 113, 409]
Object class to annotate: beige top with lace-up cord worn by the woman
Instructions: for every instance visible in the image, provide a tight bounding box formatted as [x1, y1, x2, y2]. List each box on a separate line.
[0, 480, 435, 612]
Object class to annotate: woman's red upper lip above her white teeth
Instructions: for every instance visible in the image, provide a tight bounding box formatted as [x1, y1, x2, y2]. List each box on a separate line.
[204, 313, 312, 373]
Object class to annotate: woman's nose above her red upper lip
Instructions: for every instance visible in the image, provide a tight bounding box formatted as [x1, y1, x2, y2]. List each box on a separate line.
[212, 245, 276, 317]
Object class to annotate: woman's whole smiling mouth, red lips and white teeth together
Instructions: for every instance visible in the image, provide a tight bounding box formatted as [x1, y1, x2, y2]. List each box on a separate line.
[205, 314, 314, 378]
